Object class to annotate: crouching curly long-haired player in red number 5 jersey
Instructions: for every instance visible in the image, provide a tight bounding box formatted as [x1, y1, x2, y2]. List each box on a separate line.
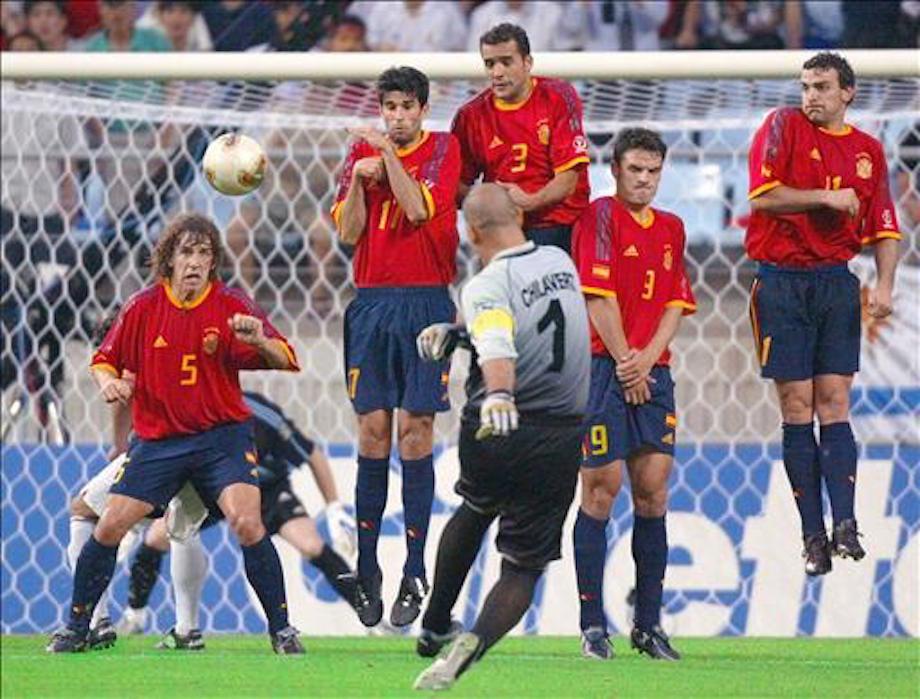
[48, 214, 304, 654]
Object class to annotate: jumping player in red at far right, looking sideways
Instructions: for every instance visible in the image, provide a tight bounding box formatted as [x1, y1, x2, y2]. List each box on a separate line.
[745, 53, 901, 575]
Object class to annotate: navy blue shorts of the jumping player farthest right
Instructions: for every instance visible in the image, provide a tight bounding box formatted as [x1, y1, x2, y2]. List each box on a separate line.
[750, 264, 861, 381]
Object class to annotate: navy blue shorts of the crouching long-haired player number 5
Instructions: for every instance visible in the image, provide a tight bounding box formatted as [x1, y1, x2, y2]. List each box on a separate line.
[110, 420, 259, 507]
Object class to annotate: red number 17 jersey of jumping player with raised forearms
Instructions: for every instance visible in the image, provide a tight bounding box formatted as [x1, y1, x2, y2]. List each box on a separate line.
[332, 131, 460, 287]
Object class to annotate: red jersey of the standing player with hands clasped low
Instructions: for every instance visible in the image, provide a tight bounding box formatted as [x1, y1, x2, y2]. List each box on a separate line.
[572, 197, 696, 365]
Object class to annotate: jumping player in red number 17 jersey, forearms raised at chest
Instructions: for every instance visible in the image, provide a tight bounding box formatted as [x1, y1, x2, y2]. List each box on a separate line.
[332, 67, 460, 626]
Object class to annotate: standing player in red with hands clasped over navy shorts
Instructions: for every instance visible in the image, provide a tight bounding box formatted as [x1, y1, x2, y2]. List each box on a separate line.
[573, 129, 696, 660]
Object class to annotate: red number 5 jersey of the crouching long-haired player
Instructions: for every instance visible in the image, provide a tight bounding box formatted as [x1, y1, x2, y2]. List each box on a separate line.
[92, 281, 300, 439]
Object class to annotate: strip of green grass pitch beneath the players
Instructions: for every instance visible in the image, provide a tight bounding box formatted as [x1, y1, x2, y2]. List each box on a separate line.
[0, 635, 920, 699]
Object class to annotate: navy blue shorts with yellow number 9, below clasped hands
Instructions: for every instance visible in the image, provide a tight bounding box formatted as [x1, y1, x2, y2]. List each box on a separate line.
[582, 357, 677, 468]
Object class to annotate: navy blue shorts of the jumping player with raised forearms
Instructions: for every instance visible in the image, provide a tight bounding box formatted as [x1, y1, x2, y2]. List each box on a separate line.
[345, 287, 457, 415]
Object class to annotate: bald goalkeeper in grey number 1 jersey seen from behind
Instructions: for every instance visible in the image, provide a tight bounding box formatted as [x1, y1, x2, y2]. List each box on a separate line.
[415, 184, 591, 690]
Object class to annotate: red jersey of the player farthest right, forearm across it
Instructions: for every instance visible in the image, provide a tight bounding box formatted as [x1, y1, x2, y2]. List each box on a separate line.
[745, 107, 901, 267]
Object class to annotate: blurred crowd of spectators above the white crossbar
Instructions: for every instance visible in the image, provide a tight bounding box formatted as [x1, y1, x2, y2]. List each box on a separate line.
[0, 0, 920, 51]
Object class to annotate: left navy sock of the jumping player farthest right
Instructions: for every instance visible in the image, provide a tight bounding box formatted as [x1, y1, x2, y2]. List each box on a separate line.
[783, 422, 824, 537]
